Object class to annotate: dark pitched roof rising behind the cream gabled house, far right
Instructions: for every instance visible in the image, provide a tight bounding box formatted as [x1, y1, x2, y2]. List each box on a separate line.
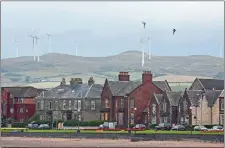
[198, 78, 224, 90]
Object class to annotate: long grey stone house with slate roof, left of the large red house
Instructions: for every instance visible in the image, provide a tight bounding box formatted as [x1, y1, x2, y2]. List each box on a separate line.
[36, 78, 103, 121]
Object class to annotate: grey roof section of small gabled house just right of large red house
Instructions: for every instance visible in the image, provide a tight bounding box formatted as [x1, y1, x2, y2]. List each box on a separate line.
[166, 91, 182, 106]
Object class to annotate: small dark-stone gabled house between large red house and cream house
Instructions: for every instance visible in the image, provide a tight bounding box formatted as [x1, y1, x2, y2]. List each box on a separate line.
[149, 91, 181, 124]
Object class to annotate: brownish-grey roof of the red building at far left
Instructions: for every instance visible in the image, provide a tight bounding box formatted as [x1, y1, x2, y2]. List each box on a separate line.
[3, 86, 44, 98]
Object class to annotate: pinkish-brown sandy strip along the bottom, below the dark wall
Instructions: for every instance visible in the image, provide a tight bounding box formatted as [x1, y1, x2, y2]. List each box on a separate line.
[0, 137, 224, 147]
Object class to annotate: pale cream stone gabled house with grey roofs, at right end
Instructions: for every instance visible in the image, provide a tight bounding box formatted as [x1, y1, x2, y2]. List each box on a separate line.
[178, 89, 222, 125]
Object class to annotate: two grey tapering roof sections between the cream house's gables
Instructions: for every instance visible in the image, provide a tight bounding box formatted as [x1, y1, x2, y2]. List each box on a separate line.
[187, 90, 222, 106]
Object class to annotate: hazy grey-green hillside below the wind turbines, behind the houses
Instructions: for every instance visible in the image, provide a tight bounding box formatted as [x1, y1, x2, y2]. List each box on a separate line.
[1, 51, 224, 86]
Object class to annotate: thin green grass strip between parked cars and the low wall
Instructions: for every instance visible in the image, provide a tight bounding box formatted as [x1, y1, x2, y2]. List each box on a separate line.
[1, 128, 224, 134]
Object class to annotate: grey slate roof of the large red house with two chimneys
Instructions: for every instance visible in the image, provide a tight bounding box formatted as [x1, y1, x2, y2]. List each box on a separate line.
[108, 81, 171, 96]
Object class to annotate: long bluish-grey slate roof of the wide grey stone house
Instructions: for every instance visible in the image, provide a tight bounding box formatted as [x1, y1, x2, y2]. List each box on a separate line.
[40, 84, 103, 98]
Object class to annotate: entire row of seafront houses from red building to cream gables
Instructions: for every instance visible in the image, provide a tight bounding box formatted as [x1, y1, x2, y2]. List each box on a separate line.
[1, 71, 224, 127]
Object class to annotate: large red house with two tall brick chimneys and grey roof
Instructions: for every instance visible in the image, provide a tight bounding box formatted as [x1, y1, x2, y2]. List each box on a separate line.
[100, 71, 171, 127]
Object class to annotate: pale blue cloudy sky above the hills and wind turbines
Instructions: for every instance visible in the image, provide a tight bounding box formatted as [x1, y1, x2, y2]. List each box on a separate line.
[1, 1, 224, 58]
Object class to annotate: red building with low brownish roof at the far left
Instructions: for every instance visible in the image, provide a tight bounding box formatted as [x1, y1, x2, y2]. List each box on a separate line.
[1, 87, 43, 122]
